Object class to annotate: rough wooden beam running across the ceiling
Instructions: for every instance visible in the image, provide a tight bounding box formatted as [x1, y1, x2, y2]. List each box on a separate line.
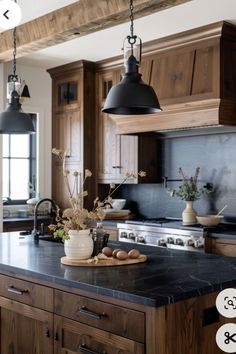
[0, 0, 192, 62]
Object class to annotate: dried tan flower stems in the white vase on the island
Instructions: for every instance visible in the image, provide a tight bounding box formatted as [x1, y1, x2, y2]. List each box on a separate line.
[49, 148, 146, 239]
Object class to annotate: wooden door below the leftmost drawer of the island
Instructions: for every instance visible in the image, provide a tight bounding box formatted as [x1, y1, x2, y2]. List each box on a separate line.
[0, 297, 53, 354]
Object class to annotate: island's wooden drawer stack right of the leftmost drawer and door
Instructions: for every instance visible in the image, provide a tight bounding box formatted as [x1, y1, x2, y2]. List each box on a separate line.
[55, 290, 145, 354]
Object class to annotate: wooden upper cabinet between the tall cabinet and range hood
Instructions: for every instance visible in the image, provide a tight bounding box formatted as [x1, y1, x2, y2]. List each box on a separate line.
[96, 66, 160, 183]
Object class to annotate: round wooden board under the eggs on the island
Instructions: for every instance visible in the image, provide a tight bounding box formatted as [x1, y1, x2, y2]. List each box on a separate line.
[61, 254, 147, 267]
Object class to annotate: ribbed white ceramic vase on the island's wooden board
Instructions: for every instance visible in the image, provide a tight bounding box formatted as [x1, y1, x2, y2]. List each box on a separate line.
[64, 229, 93, 259]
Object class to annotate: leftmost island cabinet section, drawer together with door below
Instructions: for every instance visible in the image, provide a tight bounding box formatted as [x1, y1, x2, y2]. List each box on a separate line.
[0, 275, 53, 354]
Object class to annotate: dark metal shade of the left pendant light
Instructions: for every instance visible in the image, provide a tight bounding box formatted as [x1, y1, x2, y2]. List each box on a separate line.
[0, 91, 35, 134]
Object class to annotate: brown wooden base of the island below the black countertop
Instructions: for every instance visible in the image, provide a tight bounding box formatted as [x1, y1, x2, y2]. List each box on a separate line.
[0, 268, 235, 354]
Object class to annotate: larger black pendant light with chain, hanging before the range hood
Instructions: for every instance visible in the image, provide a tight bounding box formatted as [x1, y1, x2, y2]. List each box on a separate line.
[102, 0, 161, 115]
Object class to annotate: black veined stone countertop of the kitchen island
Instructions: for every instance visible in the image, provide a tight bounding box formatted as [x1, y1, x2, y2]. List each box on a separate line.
[0, 232, 236, 307]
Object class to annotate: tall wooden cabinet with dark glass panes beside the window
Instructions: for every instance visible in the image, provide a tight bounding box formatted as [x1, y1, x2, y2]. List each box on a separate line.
[49, 61, 95, 209]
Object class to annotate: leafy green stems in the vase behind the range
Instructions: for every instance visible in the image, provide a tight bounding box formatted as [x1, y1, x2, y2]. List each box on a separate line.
[168, 167, 212, 201]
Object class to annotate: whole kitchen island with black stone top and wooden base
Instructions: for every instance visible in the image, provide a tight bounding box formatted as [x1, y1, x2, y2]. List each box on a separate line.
[0, 233, 236, 354]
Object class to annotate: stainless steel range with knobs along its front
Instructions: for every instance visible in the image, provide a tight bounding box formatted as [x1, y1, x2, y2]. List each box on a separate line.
[117, 219, 206, 252]
